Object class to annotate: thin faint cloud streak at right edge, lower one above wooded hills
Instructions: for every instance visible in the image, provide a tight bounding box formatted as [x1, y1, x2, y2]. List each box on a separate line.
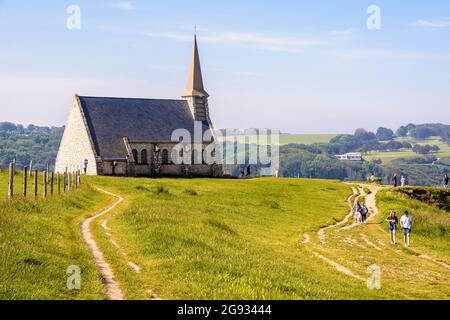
[333, 50, 450, 60]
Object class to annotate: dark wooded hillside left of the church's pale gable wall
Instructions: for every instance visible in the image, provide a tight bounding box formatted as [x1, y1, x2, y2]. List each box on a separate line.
[0, 122, 64, 170]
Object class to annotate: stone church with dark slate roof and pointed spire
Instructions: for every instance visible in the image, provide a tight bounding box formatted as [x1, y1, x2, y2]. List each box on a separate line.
[56, 38, 222, 177]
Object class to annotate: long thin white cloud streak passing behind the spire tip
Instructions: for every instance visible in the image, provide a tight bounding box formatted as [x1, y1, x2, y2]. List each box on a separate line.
[145, 31, 323, 52]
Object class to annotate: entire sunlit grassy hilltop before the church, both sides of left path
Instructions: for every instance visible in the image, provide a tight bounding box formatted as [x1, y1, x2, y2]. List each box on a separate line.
[0, 174, 450, 299]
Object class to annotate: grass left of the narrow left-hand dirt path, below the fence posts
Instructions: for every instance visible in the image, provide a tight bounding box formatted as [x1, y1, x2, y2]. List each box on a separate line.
[0, 173, 110, 299]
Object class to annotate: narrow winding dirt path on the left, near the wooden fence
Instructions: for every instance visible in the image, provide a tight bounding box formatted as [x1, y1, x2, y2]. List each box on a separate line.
[81, 189, 124, 300]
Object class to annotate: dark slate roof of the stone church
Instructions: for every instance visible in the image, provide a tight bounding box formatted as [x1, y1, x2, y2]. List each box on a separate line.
[79, 97, 209, 159]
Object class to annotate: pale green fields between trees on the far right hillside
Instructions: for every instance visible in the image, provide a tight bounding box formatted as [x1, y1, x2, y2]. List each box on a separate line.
[364, 138, 450, 164]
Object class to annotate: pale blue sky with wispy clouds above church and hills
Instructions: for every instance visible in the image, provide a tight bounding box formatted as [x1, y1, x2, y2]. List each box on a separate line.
[0, 0, 450, 133]
